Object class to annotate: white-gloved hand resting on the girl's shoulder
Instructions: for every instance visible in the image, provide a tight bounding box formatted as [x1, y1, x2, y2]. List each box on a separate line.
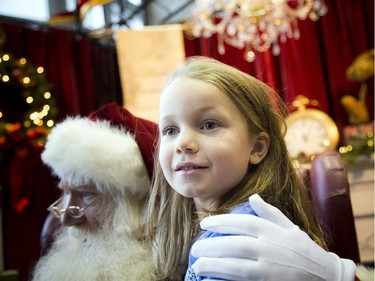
[192, 195, 356, 281]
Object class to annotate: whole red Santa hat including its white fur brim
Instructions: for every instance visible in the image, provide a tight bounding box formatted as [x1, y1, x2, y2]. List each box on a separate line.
[42, 103, 158, 196]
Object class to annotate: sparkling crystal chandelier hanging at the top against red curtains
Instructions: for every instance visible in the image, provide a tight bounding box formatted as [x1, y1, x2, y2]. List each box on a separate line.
[189, 0, 327, 62]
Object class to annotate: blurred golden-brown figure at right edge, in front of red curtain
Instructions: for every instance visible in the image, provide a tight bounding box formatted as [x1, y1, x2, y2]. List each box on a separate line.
[340, 49, 374, 125]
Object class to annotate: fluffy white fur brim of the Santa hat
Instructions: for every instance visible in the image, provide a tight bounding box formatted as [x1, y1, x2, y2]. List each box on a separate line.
[42, 117, 150, 196]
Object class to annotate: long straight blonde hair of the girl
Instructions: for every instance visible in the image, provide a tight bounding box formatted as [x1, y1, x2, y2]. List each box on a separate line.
[147, 57, 325, 280]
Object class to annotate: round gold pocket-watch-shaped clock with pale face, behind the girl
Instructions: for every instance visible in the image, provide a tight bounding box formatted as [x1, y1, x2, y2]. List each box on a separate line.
[285, 96, 339, 161]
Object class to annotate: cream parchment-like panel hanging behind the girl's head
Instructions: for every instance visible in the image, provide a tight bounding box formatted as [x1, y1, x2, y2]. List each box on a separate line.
[115, 24, 185, 122]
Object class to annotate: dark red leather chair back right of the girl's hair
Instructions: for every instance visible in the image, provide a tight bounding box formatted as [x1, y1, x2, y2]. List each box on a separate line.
[310, 151, 360, 262]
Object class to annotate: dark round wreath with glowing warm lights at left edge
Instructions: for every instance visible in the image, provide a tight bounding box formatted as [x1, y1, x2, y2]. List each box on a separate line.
[0, 51, 57, 138]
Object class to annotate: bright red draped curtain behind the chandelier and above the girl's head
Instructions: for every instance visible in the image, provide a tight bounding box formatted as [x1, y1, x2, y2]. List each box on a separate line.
[185, 0, 374, 137]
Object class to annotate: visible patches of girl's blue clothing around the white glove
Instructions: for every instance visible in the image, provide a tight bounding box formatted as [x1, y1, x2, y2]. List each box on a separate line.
[185, 201, 256, 281]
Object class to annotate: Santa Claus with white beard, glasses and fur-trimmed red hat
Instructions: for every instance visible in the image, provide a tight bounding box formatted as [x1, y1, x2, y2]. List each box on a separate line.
[32, 104, 158, 281]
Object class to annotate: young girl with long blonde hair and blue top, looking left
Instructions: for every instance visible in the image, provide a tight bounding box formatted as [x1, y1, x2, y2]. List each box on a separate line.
[147, 57, 325, 280]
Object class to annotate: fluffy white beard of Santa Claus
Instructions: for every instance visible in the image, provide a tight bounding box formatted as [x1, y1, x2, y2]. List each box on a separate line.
[32, 227, 155, 281]
